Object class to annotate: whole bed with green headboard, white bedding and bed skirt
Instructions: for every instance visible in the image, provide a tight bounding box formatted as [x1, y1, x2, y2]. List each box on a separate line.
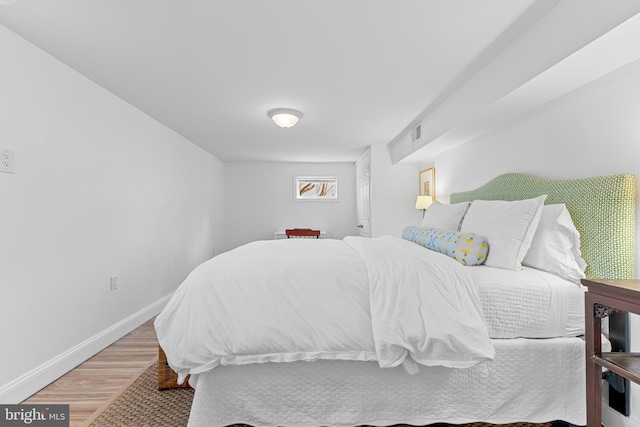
[156, 174, 636, 427]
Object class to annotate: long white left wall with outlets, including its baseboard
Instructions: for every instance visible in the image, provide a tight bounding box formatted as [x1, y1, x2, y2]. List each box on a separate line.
[0, 26, 224, 403]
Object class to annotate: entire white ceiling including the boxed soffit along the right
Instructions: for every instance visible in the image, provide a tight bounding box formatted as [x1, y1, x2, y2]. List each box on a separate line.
[0, 0, 640, 162]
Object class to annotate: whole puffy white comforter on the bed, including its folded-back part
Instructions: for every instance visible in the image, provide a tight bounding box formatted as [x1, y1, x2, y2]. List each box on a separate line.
[155, 236, 495, 381]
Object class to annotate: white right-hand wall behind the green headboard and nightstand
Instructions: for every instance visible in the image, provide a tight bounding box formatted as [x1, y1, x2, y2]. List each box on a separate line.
[420, 57, 640, 427]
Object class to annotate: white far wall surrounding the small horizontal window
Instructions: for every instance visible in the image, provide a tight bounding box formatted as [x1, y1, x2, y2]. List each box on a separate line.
[222, 162, 358, 250]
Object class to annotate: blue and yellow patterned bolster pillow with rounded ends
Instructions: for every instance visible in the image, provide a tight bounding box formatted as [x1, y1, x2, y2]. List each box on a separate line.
[402, 226, 489, 265]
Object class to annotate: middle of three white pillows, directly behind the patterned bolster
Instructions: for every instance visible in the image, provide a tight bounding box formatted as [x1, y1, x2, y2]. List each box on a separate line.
[460, 194, 547, 270]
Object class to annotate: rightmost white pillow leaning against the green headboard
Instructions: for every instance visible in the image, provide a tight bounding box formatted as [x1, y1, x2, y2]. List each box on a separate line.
[522, 204, 587, 284]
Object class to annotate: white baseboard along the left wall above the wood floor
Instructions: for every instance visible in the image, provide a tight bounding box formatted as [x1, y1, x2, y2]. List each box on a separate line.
[0, 294, 172, 404]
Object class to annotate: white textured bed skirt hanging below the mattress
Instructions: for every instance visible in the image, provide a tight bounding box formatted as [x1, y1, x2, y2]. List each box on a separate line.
[189, 338, 586, 427]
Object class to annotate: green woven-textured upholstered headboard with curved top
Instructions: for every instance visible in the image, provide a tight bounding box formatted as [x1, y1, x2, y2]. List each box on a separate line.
[450, 173, 636, 279]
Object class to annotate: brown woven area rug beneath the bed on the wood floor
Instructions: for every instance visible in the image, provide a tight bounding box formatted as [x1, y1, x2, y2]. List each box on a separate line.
[89, 362, 552, 427]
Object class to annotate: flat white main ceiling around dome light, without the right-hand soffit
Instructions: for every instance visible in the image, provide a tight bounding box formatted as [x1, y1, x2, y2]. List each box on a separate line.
[0, 0, 544, 162]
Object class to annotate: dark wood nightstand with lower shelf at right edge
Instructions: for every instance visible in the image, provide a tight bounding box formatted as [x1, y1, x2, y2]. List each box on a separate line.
[582, 279, 640, 427]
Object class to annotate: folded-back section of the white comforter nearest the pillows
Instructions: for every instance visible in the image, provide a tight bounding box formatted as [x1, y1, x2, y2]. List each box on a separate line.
[345, 236, 495, 368]
